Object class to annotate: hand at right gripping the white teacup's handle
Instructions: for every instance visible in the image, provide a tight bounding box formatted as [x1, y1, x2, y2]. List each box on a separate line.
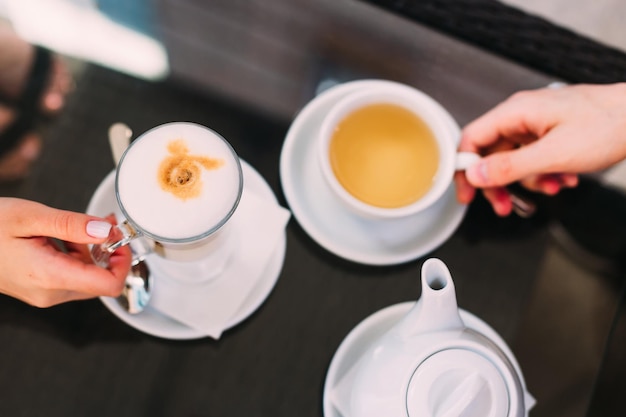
[455, 83, 626, 216]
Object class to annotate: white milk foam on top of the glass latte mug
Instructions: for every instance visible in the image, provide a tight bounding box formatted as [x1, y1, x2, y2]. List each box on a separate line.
[116, 123, 241, 241]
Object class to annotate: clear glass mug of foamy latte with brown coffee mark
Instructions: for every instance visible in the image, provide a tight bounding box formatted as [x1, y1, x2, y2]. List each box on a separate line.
[91, 122, 243, 276]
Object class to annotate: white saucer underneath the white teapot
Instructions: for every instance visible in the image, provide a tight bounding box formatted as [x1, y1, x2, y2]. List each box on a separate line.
[323, 301, 534, 417]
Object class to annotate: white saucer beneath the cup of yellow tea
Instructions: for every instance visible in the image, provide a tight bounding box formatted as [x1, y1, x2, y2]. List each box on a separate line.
[280, 80, 467, 265]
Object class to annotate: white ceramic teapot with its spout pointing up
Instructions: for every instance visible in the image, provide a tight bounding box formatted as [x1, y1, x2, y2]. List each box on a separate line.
[325, 259, 535, 417]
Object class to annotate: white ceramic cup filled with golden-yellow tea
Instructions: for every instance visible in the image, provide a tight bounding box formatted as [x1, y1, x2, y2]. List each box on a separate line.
[317, 82, 480, 219]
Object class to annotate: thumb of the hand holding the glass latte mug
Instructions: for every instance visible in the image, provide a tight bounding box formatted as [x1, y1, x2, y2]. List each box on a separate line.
[20, 200, 111, 244]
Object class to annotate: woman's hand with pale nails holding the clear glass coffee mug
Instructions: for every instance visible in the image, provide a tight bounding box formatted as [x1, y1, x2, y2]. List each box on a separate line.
[0, 198, 131, 307]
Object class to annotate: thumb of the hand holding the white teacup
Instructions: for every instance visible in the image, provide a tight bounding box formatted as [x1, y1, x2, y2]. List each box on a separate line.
[465, 145, 542, 188]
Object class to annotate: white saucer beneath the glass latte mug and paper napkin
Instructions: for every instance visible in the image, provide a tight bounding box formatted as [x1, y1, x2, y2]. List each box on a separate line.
[87, 160, 287, 339]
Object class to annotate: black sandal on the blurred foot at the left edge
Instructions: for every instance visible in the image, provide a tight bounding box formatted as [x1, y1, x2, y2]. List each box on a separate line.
[0, 46, 52, 158]
